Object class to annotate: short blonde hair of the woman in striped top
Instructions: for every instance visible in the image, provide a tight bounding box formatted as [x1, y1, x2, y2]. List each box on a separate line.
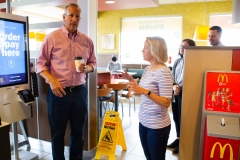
[146, 37, 168, 63]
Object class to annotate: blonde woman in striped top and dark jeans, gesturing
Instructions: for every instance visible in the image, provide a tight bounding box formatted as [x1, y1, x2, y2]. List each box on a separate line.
[122, 37, 173, 160]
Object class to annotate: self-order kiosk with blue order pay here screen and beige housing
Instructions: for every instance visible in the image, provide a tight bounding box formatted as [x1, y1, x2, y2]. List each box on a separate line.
[0, 12, 34, 123]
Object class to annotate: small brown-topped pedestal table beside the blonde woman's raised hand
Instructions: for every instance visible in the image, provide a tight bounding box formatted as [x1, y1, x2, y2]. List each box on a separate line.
[106, 79, 128, 112]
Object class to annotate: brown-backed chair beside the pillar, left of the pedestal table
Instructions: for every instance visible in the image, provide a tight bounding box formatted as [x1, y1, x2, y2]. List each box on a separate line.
[98, 88, 112, 118]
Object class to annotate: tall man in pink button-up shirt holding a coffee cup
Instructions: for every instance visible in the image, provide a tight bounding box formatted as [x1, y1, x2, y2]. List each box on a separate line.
[36, 3, 96, 160]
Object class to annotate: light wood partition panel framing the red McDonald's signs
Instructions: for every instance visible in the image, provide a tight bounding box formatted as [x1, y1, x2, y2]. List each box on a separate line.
[179, 47, 232, 160]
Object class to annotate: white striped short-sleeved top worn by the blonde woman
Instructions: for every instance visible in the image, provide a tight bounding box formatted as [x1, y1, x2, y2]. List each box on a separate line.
[138, 66, 173, 129]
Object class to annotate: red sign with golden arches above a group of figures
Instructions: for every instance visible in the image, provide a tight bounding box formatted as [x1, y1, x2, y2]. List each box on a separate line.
[205, 72, 240, 113]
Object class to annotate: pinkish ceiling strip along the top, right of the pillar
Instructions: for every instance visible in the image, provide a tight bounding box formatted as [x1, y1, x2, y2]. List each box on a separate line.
[98, 0, 232, 11]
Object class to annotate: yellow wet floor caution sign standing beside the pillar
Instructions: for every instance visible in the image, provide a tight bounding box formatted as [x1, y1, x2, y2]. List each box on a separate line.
[95, 111, 127, 160]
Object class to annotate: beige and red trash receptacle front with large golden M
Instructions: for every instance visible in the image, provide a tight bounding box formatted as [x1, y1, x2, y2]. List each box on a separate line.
[202, 115, 240, 160]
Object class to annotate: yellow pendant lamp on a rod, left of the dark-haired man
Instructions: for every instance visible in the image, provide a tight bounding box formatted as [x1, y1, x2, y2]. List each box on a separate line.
[193, 1, 210, 41]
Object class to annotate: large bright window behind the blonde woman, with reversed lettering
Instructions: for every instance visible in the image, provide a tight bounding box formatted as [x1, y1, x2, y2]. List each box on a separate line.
[120, 16, 182, 65]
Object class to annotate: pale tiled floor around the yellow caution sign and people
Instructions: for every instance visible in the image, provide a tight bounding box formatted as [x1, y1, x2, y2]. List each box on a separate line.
[12, 97, 178, 160]
